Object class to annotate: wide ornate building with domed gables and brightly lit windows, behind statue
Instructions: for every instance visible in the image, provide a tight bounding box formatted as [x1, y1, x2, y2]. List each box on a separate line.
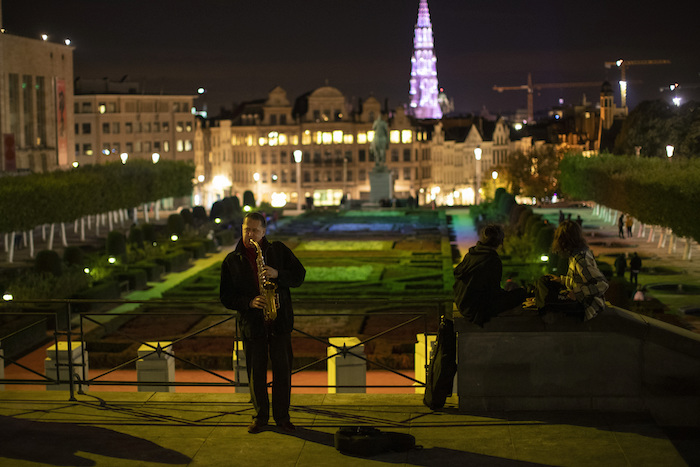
[195, 86, 438, 210]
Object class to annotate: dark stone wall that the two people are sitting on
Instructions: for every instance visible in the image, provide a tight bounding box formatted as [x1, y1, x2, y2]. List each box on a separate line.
[455, 307, 700, 426]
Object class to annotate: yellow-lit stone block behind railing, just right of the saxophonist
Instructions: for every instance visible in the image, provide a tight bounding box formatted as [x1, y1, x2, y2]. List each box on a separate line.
[328, 337, 367, 394]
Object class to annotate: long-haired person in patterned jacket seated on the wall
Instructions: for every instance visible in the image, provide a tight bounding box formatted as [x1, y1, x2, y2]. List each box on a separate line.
[546, 221, 608, 321]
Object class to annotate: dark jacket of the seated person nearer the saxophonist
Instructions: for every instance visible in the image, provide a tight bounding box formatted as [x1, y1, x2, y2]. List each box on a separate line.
[454, 242, 505, 325]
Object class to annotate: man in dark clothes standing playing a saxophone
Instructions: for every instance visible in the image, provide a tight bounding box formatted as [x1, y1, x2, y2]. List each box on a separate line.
[220, 212, 306, 434]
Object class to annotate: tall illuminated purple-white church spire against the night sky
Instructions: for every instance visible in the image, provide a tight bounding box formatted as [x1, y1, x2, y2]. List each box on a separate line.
[408, 0, 442, 119]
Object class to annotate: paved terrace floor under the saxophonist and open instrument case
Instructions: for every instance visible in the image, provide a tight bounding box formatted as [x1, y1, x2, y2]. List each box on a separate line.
[0, 391, 700, 467]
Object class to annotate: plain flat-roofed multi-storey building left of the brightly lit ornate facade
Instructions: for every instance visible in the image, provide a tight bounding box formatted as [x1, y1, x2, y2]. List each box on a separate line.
[71, 80, 195, 164]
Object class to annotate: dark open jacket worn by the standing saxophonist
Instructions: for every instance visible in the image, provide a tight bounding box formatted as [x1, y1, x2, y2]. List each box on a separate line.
[219, 237, 306, 339]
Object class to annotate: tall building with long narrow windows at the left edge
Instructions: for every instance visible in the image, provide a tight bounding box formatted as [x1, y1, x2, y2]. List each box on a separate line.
[0, 32, 73, 172]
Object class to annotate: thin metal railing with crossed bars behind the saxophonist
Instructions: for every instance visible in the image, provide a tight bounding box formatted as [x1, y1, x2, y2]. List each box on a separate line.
[0, 296, 452, 400]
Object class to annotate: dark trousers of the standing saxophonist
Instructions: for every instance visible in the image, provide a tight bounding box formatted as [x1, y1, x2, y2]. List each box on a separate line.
[243, 333, 294, 423]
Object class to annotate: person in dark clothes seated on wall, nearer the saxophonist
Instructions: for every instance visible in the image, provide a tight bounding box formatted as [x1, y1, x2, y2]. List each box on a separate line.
[454, 224, 527, 326]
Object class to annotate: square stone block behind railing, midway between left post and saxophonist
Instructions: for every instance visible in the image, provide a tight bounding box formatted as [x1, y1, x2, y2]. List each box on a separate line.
[136, 341, 175, 392]
